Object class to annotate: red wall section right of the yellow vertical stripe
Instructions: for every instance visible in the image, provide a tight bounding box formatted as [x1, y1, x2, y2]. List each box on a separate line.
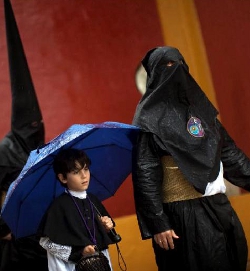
[195, 0, 250, 156]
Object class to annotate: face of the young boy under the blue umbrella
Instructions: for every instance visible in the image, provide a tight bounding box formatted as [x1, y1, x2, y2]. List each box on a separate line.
[58, 162, 90, 191]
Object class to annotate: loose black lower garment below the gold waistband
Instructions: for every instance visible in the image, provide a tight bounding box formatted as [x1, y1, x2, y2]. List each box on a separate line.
[153, 194, 248, 271]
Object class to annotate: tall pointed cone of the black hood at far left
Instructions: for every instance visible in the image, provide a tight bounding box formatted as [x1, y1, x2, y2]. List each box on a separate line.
[4, 0, 42, 135]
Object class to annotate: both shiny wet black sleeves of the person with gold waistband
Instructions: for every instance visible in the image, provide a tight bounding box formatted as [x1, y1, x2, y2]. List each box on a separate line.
[132, 132, 250, 239]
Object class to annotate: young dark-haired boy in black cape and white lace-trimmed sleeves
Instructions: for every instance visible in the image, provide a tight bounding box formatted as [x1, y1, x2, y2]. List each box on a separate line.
[39, 149, 114, 271]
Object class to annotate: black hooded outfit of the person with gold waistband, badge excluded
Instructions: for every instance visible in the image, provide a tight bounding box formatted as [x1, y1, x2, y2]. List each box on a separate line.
[132, 47, 250, 271]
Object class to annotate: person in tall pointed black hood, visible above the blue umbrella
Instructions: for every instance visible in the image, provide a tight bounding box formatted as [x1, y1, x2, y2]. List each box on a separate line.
[0, 0, 44, 191]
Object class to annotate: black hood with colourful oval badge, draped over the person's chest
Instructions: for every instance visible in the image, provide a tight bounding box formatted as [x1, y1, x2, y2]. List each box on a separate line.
[133, 46, 220, 194]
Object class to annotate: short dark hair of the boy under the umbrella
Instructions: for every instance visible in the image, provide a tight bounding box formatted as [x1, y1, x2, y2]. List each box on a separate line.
[53, 148, 91, 185]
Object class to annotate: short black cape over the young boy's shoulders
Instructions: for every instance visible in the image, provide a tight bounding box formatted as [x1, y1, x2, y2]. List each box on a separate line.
[38, 193, 113, 250]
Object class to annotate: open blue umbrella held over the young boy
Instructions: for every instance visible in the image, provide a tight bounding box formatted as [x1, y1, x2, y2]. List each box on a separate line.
[1, 122, 139, 238]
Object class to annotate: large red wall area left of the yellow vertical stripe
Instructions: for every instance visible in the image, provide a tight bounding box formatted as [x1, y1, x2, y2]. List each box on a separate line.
[0, 0, 163, 216]
